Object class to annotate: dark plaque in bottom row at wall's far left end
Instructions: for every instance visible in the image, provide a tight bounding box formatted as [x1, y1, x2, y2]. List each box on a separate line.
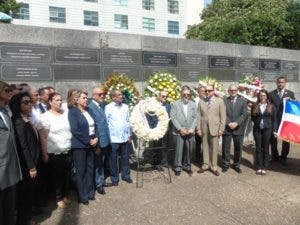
[1, 64, 52, 81]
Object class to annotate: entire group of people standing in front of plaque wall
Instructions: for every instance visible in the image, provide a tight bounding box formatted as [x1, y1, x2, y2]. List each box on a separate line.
[0, 77, 294, 225]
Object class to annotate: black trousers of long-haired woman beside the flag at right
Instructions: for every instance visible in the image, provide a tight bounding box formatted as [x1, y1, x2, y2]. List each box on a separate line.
[253, 128, 272, 169]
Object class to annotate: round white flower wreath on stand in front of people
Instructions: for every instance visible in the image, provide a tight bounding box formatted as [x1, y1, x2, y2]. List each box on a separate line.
[130, 98, 169, 141]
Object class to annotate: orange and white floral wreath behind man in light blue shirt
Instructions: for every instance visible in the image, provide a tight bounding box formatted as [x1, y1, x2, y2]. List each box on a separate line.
[103, 73, 139, 109]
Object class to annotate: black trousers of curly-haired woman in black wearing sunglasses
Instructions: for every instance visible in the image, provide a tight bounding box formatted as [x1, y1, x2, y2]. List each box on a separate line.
[17, 174, 36, 225]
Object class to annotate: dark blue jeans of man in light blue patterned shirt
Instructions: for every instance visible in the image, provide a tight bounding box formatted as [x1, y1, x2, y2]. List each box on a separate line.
[109, 141, 130, 183]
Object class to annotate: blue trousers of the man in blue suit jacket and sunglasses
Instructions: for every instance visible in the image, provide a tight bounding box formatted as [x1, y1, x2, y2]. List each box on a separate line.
[95, 145, 111, 187]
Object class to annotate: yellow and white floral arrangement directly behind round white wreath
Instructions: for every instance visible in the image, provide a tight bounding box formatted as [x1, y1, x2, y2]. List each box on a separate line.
[145, 71, 181, 102]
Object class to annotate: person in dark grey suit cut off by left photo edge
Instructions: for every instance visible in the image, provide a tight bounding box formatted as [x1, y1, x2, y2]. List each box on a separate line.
[0, 81, 22, 225]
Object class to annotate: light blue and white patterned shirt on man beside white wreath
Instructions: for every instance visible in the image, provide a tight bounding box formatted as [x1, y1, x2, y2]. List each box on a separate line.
[105, 102, 131, 143]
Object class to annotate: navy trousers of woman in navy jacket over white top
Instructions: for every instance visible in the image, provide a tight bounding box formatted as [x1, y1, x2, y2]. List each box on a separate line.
[72, 149, 95, 202]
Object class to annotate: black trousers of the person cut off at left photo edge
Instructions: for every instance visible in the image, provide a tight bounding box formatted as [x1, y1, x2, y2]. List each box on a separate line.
[0, 184, 17, 225]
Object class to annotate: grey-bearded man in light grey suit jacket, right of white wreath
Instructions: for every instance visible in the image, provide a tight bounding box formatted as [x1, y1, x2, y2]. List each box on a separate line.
[170, 86, 197, 176]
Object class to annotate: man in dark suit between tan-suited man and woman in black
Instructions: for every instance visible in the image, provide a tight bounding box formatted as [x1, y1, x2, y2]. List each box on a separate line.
[222, 84, 248, 173]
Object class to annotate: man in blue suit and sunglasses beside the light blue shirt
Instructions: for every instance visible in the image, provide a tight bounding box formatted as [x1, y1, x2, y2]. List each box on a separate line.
[88, 87, 110, 195]
